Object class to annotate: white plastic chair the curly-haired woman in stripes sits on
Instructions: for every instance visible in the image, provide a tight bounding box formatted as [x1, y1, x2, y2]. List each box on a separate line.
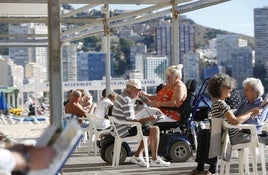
[220, 120, 259, 175]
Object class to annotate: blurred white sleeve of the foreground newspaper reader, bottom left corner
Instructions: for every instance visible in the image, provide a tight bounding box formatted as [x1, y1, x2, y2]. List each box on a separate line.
[0, 148, 16, 172]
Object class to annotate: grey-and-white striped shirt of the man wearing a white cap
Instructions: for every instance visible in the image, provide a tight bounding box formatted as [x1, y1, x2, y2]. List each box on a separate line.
[112, 90, 135, 137]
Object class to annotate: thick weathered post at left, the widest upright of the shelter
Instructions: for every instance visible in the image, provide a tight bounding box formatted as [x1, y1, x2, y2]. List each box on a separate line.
[48, 0, 63, 126]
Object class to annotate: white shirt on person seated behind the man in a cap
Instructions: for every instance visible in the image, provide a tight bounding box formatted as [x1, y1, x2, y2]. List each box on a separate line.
[94, 98, 113, 129]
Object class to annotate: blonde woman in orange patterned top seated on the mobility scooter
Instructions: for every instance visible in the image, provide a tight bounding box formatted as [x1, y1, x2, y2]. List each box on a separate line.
[140, 64, 187, 121]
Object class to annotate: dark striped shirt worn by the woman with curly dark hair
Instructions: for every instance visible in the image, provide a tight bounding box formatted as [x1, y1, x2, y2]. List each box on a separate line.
[212, 100, 240, 138]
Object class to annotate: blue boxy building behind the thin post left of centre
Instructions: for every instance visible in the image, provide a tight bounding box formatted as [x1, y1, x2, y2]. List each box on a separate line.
[77, 52, 114, 81]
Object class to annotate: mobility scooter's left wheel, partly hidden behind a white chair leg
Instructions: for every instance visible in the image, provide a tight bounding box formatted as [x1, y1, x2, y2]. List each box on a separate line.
[101, 144, 127, 165]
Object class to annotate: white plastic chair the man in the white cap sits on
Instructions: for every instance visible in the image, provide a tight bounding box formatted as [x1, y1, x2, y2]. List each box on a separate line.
[108, 116, 149, 168]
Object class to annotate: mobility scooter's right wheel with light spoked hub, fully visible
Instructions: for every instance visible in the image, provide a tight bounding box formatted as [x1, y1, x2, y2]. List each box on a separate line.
[169, 141, 191, 162]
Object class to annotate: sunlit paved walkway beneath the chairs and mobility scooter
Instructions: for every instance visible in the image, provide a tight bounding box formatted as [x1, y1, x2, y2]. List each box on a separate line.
[63, 143, 268, 175]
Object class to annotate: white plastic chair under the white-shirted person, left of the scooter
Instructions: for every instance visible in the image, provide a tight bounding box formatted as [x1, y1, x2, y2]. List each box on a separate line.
[87, 113, 111, 156]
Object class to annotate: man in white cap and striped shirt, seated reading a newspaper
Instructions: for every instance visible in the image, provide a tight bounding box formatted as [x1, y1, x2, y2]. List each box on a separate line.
[112, 79, 170, 167]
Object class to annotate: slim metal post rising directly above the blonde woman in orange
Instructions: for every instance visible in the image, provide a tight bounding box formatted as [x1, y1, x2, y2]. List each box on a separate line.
[171, 0, 180, 65]
